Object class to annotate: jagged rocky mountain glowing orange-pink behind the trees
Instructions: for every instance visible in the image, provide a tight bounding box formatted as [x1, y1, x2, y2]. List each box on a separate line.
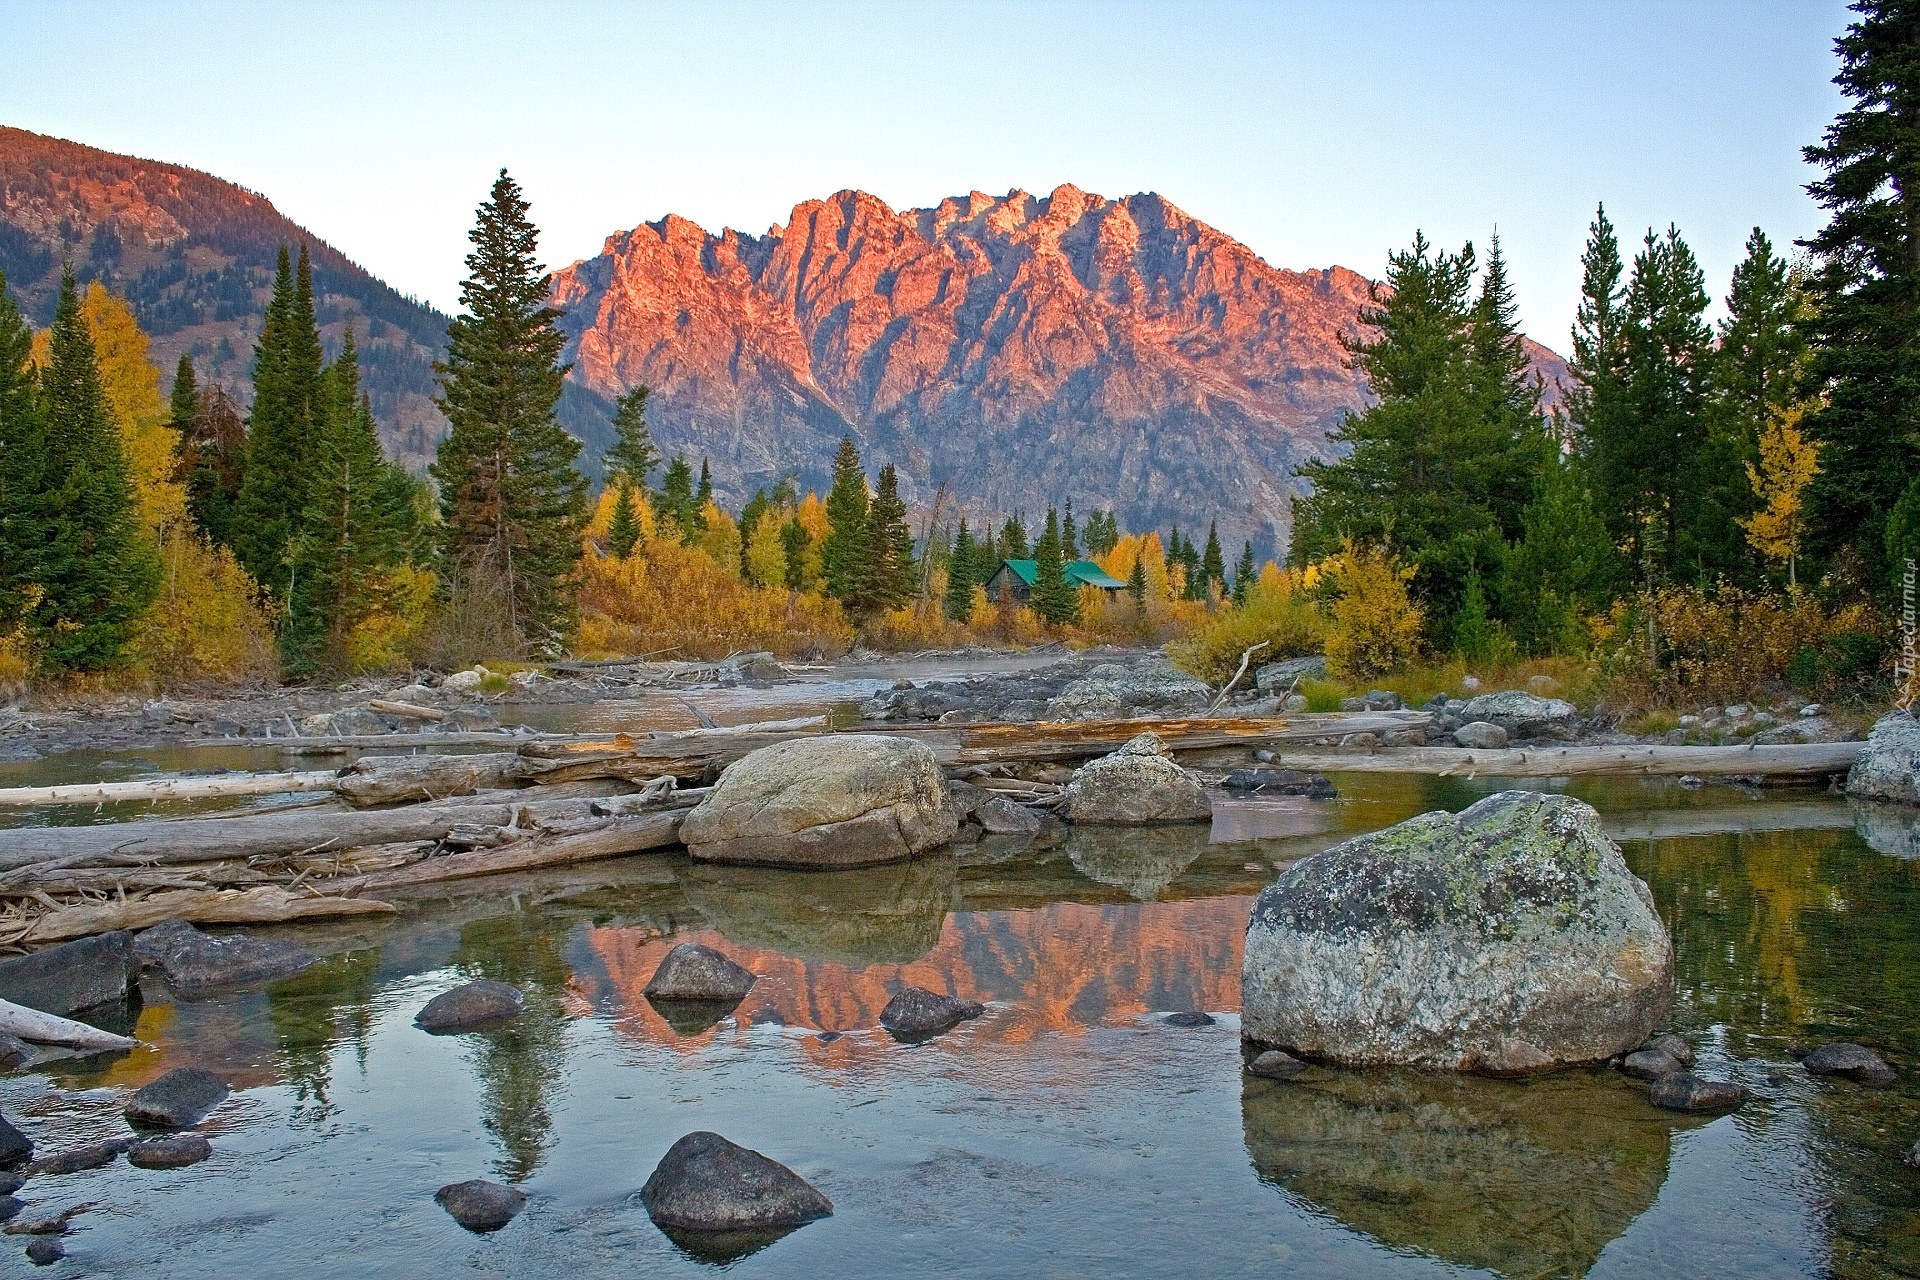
[553, 186, 1565, 551]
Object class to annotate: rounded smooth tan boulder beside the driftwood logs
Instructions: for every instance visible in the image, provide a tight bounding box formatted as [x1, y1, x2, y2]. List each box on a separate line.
[680, 733, 960, 867]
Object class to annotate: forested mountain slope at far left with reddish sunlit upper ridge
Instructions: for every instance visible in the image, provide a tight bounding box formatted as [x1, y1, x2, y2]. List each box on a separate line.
[0, 127, 447, 468]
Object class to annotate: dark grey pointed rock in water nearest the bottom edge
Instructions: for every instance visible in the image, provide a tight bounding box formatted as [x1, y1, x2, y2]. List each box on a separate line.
[639, 1132, 833, 1232]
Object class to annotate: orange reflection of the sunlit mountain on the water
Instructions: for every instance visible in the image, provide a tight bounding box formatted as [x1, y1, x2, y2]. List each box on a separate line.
[574, 896, 1252, 1063]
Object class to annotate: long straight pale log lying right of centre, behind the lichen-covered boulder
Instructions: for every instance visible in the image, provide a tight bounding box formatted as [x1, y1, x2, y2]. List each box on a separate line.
[1273, 743, 1866, 777]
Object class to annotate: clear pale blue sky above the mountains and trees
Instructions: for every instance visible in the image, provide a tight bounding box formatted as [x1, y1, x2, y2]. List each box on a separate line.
[0, 0, 1847, 351]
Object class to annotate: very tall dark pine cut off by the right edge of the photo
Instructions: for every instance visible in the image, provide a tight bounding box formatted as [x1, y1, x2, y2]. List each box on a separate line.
[1805, 0, 1920, 595]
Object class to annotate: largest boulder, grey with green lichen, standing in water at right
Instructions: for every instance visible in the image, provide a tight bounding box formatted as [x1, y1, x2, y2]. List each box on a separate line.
[1240, 791, 1674, 1075]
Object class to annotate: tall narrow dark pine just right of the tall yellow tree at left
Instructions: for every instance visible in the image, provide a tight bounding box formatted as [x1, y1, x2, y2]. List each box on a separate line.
[232, 246, 324, 606]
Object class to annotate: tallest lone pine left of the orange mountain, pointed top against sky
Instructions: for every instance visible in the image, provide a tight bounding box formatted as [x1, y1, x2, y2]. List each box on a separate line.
[432, 169, 586, 651]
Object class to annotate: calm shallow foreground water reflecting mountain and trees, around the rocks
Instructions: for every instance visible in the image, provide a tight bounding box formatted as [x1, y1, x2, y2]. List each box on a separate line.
[0, 775, 1920, 1276]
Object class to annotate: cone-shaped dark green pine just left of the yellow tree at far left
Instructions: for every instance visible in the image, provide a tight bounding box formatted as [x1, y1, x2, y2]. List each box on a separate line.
[27, 271, 159, 674]
